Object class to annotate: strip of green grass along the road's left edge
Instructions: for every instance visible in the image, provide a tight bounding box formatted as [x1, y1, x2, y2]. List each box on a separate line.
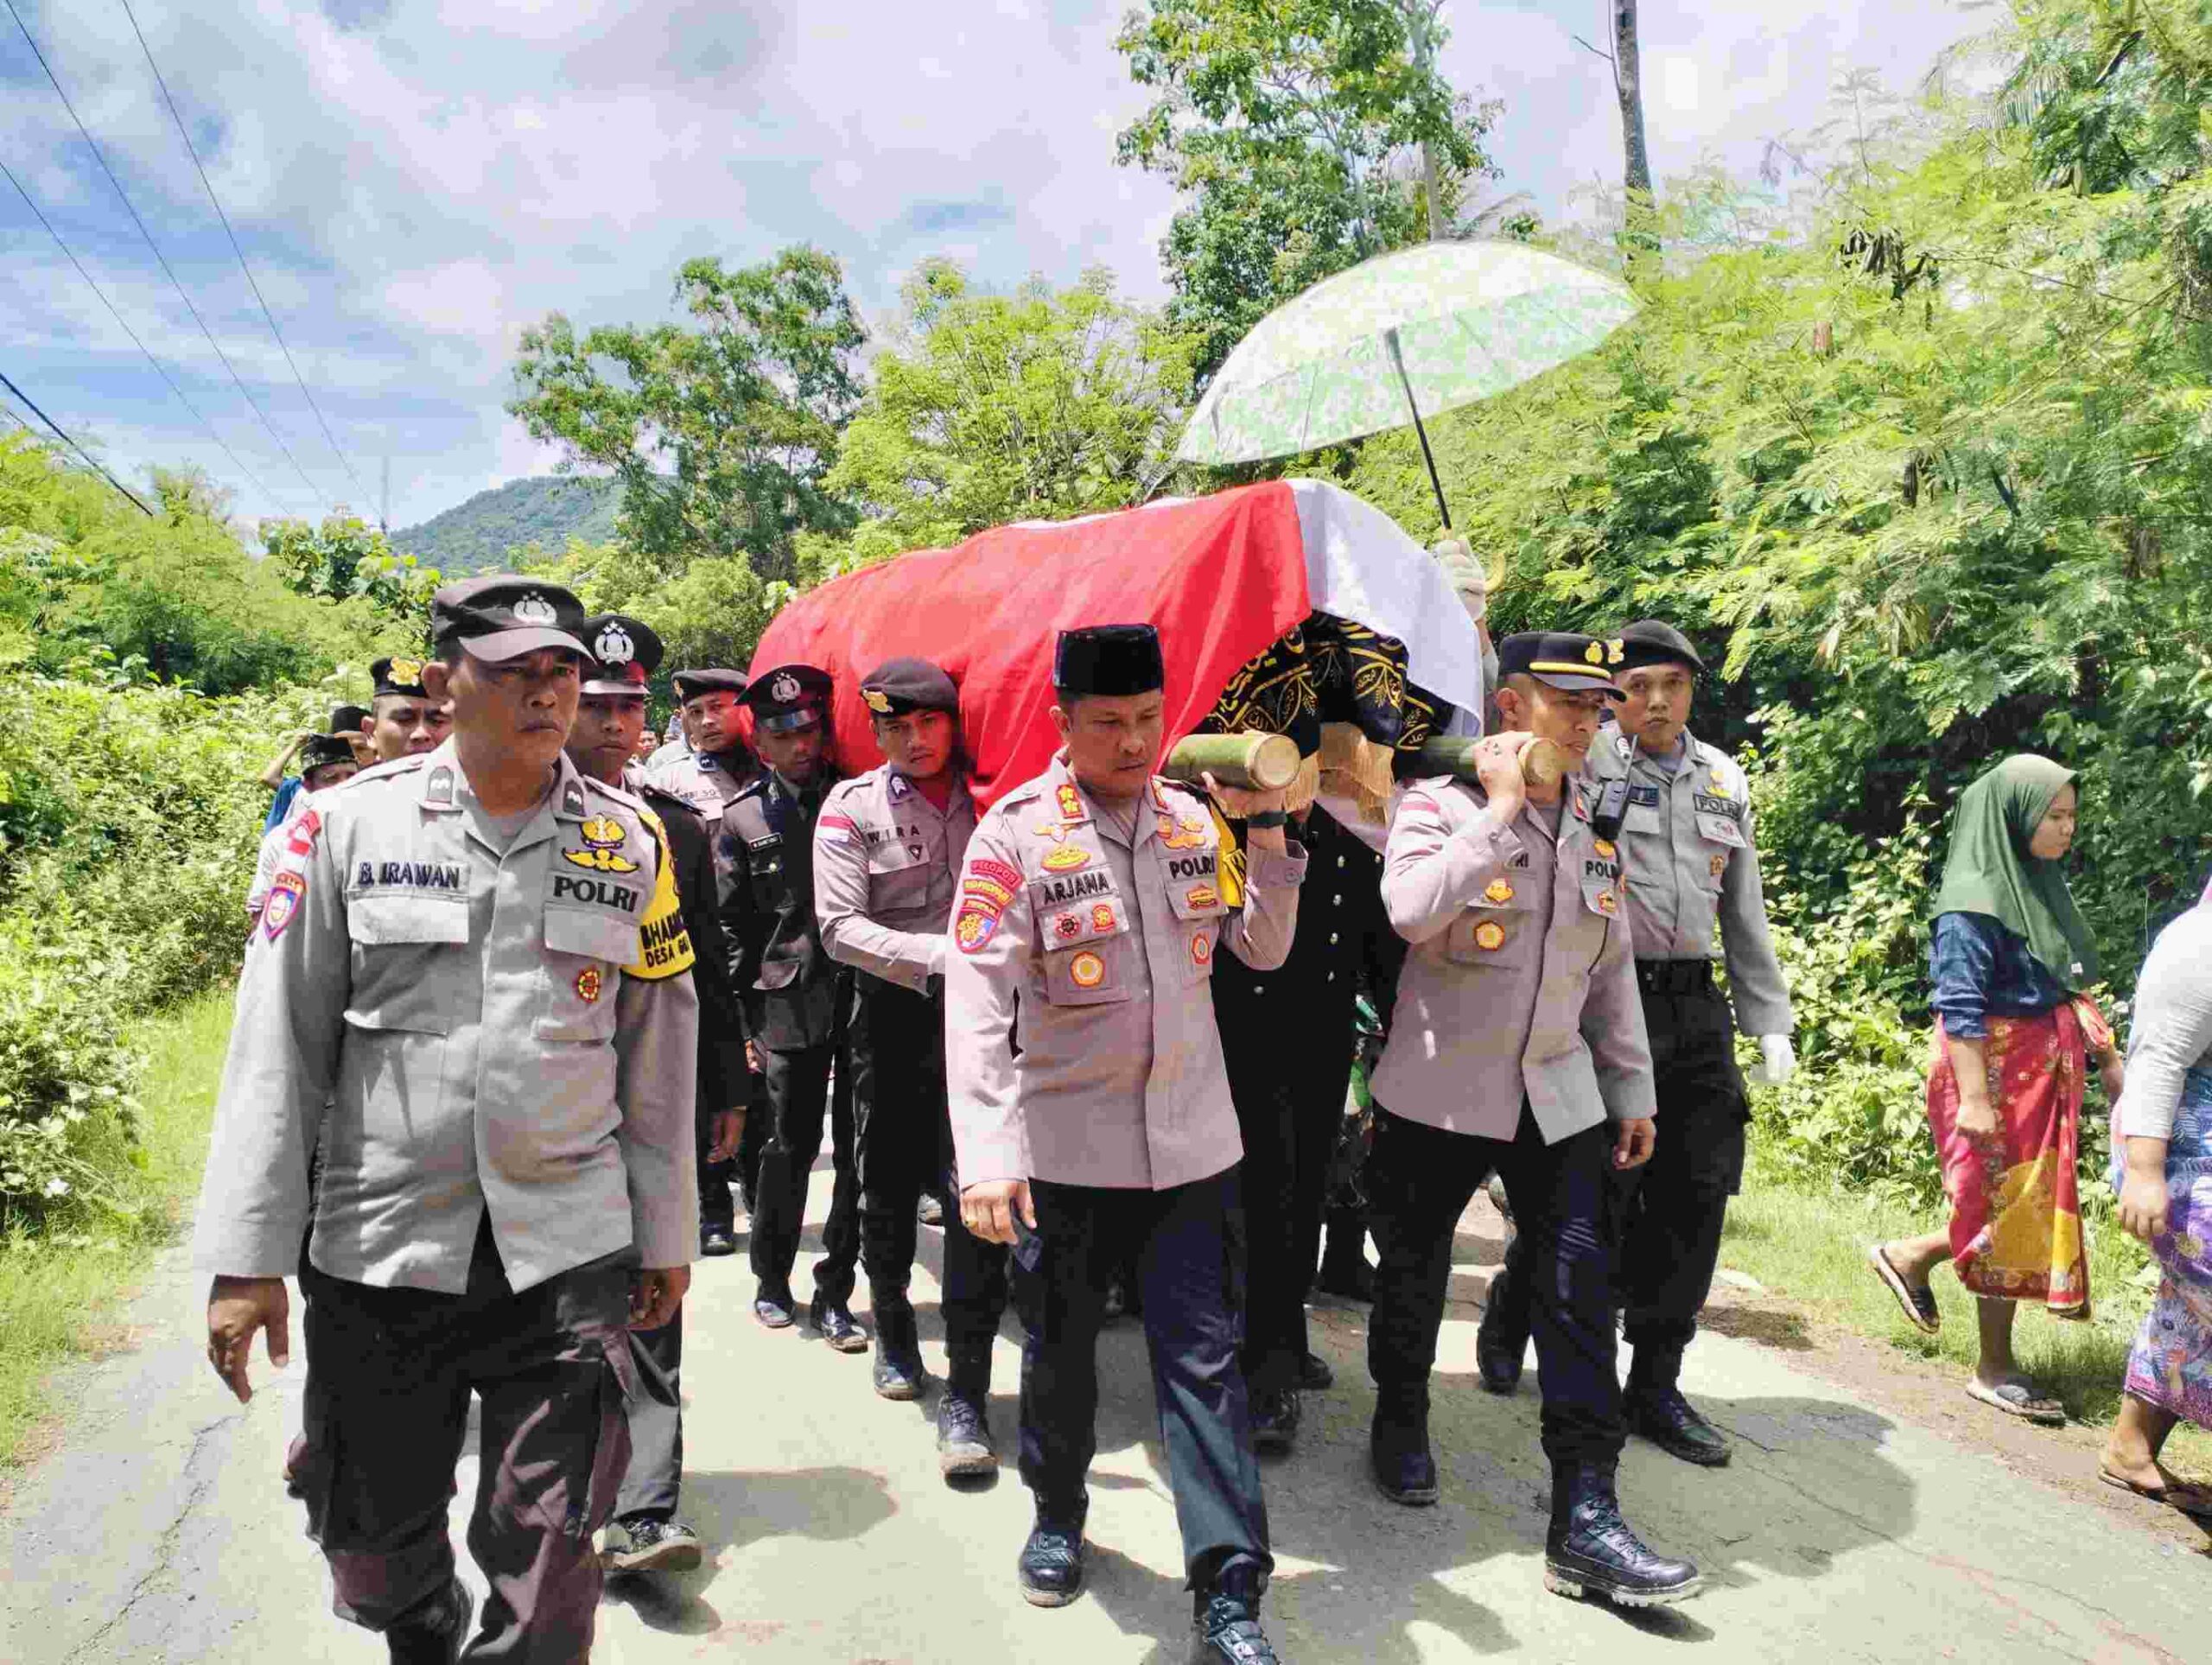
[0, 986, 230, 1468]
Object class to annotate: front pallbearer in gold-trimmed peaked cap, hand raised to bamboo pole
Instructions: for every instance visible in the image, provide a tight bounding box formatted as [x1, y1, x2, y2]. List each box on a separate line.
[1367, 632, 1699, 1603]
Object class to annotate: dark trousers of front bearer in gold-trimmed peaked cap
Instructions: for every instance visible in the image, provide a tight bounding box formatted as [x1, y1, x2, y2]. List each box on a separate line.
[1367, 1103, 1624, 1466]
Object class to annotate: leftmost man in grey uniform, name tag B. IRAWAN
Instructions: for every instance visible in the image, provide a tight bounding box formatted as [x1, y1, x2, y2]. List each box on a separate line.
[194, 575, 699, 1661]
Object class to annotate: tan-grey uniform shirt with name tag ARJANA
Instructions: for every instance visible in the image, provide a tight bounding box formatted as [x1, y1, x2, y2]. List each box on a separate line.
[944, 752, 1305, 1190]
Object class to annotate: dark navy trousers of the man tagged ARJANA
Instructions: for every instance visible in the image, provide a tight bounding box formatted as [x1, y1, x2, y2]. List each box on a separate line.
[1013, 1167, 1274, 1592]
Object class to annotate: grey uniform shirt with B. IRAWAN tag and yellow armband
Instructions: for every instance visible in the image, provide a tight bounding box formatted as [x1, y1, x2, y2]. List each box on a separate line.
[193, 740, 699, 1293]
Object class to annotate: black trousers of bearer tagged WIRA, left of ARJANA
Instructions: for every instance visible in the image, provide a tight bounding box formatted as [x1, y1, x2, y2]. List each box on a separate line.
[849, 975, 1007, 1362]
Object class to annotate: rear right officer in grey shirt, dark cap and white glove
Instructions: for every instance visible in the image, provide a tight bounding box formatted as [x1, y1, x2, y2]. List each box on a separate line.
[1478, 620, 1796, 1468]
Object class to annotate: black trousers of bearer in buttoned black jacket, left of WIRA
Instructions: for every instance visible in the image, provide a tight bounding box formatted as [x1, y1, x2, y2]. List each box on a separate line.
[750, 1041, 861, 1300]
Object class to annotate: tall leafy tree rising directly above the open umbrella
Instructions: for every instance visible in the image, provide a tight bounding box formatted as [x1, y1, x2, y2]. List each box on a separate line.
[1115, 0, 1500, 378]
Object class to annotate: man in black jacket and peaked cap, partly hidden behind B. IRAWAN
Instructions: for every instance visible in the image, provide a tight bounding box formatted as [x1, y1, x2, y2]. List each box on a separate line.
[566, 613, 752, 1573]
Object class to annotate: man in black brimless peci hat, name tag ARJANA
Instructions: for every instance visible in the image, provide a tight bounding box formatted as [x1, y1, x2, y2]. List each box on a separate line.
[944, 624, 1305, 1665]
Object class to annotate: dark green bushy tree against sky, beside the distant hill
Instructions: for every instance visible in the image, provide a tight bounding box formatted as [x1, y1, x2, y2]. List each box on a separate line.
[506, 248, 865, 577]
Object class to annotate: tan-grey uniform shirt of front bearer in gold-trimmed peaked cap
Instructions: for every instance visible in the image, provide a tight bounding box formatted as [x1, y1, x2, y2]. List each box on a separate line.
[1374, 778, 1656, 1146]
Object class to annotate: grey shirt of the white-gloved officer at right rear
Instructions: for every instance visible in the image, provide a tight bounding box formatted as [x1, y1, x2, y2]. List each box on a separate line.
[1584, 730, 1796, 1035]
